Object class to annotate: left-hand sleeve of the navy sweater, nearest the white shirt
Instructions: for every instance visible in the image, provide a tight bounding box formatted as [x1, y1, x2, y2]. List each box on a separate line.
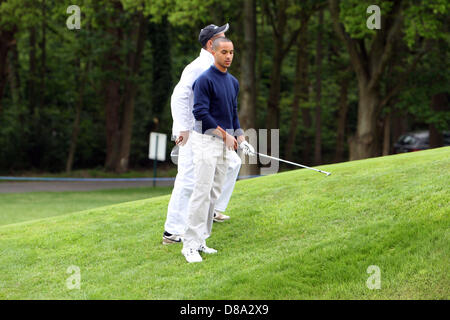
[192, 76, 217, 132]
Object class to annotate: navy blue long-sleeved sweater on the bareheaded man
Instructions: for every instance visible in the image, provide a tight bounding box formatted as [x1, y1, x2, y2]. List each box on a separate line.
[192, 65, 242, 136]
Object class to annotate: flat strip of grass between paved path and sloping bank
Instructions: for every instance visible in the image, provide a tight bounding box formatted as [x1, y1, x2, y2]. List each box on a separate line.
[0, 187, 172, 226]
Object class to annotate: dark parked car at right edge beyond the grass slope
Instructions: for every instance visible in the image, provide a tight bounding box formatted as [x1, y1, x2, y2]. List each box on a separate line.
[394, 130, 450, 153]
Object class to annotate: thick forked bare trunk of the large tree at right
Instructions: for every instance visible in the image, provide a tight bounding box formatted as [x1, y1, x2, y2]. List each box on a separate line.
[329, 0, 406, 160]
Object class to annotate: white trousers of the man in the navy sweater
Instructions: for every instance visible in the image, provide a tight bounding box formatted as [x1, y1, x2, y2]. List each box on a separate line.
[183, 132, 235, 249]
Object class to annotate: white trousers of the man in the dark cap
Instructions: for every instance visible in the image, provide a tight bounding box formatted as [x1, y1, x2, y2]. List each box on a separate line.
[164, 132, 241, 235]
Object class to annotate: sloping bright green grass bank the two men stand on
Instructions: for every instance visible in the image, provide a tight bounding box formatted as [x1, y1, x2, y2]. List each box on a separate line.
[0, 148, 450, 299]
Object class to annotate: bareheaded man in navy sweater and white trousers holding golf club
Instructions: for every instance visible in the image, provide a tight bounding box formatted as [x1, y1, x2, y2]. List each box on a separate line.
[181, 37, 255, 262]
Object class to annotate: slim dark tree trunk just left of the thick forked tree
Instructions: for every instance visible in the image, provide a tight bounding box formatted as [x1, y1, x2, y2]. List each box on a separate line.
[334, 77, 350, 162]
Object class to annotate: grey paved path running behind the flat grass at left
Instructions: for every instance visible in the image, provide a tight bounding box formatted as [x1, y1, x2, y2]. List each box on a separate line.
[0, 181, 174, 193]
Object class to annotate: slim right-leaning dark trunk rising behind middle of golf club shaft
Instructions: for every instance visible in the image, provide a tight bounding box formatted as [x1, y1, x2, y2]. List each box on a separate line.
[285, 14, 309, 161]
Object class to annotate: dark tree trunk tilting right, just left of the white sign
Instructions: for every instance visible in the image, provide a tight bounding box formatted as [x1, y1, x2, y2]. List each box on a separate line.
[115, 13, 147, 173]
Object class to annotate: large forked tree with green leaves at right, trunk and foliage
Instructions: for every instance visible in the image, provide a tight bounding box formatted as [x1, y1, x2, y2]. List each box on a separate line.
[329, 0, 448, 160]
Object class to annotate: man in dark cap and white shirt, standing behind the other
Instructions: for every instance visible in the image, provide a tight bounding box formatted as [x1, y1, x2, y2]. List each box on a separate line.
[163, 23, 241, 244]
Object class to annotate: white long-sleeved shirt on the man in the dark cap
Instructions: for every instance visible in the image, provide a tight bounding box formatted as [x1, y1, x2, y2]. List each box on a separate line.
[170, 49, 214, 136]
